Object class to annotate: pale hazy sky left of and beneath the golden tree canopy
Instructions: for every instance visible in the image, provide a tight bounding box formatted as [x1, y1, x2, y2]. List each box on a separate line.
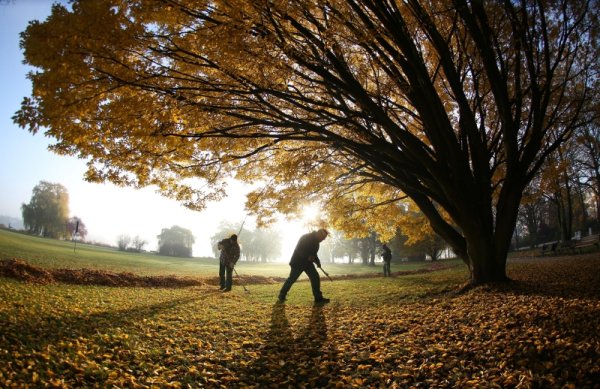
[0, 0, 304, 261]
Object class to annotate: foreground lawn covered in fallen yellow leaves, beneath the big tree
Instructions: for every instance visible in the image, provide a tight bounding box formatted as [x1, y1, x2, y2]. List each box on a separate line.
[0, 254, 600, 388]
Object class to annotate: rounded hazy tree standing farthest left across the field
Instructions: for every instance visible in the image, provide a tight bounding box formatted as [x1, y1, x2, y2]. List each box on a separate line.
[21, 181, 69, 239]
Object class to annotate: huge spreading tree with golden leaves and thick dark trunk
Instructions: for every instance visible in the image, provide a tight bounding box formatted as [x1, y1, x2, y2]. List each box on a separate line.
[15, 0, 598, 283]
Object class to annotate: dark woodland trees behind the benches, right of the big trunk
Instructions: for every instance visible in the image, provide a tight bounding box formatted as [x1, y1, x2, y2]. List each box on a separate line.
[513, 119, 600, 248]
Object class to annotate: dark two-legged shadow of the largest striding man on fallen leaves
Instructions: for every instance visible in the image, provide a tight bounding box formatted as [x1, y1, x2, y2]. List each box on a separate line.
[239, 303, 328, 387]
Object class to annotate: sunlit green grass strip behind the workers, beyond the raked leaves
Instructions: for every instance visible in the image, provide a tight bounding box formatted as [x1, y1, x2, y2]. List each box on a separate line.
[0, 229, 448, 277]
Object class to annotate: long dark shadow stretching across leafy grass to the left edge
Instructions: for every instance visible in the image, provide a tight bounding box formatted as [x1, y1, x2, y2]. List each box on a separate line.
[0, 296, 204, 350]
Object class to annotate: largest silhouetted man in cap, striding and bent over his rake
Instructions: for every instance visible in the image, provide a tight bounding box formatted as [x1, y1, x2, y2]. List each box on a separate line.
[278, 228, 329, 304]
